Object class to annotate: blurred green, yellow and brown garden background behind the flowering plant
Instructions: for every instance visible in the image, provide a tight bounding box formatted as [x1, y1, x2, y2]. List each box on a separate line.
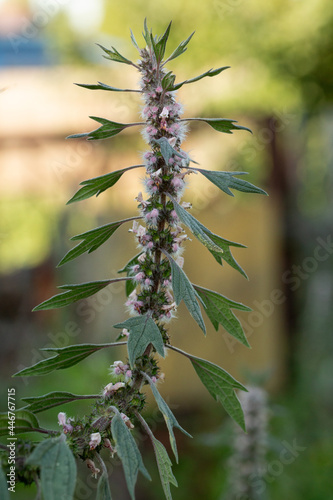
[0, 0, 333, 500]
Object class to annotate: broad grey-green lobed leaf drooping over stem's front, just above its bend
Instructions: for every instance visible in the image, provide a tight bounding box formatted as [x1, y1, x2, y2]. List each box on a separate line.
[114, 314, 165, 368]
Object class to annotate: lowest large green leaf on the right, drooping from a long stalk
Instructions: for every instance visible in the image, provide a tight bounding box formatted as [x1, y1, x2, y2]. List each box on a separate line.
[188, 355, 247, 431]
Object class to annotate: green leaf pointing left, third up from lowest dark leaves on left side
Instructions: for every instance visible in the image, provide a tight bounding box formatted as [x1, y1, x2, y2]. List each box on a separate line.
[33, 278, 120, 311]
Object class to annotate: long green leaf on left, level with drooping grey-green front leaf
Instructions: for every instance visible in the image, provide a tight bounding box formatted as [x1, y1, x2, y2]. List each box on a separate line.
[13, 342, 126, 377]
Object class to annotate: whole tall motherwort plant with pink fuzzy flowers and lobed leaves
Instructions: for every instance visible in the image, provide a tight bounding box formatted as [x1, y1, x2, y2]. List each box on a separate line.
[0, 22, 265, 499]
